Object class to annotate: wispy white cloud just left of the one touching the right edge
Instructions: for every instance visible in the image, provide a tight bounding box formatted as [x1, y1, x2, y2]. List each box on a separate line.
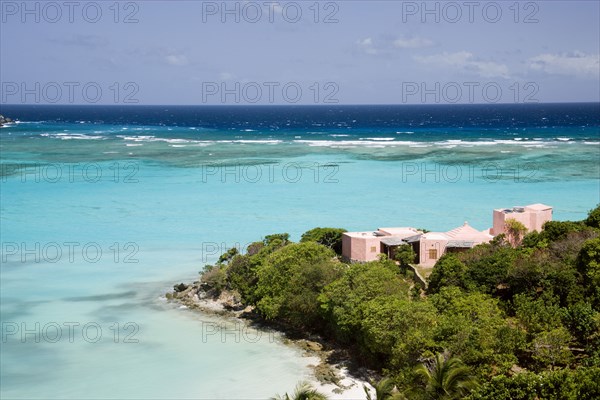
[414, 51, 509, 79]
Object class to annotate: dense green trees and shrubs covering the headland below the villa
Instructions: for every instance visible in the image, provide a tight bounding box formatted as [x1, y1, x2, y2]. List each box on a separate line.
[202, 211, 600, 399]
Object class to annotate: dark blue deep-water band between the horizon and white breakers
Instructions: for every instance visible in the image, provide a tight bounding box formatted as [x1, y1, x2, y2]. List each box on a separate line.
[0, 103, 600, 136]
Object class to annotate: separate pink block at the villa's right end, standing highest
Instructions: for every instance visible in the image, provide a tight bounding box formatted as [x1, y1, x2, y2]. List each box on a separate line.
[490, 203, 552, 236]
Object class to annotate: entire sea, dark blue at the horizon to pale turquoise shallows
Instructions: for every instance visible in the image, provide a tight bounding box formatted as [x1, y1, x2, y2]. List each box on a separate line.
[0, 103, 600, 399]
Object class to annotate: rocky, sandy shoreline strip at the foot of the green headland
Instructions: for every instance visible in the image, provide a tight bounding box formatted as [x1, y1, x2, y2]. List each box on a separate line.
[166, 281, 374, 398]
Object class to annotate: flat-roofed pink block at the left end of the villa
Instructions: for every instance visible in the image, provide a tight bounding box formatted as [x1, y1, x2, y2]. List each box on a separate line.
[342, 228, 423, 262]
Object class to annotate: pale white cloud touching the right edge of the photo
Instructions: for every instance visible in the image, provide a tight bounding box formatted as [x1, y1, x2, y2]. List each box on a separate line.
[529, 51, 600, 78]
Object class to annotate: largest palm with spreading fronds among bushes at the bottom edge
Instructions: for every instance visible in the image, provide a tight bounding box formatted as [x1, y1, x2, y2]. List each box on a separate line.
[415, 353, 477, 400]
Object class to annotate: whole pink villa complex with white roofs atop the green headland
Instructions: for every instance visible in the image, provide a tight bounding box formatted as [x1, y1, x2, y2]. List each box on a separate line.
[342, 204, 552, 267]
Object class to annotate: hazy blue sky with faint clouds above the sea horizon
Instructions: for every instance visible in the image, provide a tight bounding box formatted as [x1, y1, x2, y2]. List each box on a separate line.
[0, 0, 600, 105]
